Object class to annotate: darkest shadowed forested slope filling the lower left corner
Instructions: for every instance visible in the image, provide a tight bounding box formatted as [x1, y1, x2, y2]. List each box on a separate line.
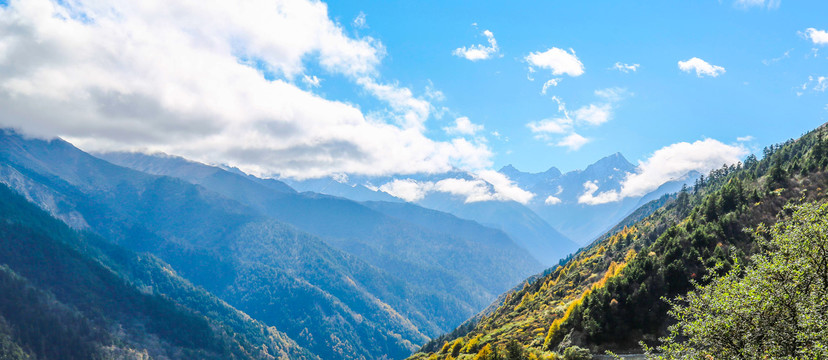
[0, 185, 316, 359]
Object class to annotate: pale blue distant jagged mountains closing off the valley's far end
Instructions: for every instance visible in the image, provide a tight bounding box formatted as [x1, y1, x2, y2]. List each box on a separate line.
[283, 153, 699, 260]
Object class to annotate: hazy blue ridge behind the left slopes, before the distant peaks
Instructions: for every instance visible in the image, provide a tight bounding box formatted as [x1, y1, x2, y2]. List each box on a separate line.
[98, 153, 542, 326]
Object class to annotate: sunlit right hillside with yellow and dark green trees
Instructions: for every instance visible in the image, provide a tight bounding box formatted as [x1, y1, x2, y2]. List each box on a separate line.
[414, 126, 828, 359]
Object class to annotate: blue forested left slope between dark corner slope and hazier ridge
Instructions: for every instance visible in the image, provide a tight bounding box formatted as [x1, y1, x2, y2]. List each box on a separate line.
[0, 133, 430, 359]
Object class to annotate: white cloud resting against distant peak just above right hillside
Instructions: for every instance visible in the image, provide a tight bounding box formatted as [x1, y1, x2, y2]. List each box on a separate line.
[578, 139, 747, 205]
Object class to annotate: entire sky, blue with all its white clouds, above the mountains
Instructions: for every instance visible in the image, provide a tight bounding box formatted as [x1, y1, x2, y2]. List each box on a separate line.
[0, 0, 828, 183]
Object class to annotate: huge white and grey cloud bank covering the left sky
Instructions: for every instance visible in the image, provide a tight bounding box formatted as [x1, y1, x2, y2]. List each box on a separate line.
[0, 0, 492, 178]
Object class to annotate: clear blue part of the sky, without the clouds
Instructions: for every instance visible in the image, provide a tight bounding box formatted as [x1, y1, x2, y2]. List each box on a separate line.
[322, 1, 828, 171]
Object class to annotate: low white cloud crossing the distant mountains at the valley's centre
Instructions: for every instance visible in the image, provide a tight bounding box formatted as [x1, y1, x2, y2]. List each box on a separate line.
[379, 170, 535, 204]
